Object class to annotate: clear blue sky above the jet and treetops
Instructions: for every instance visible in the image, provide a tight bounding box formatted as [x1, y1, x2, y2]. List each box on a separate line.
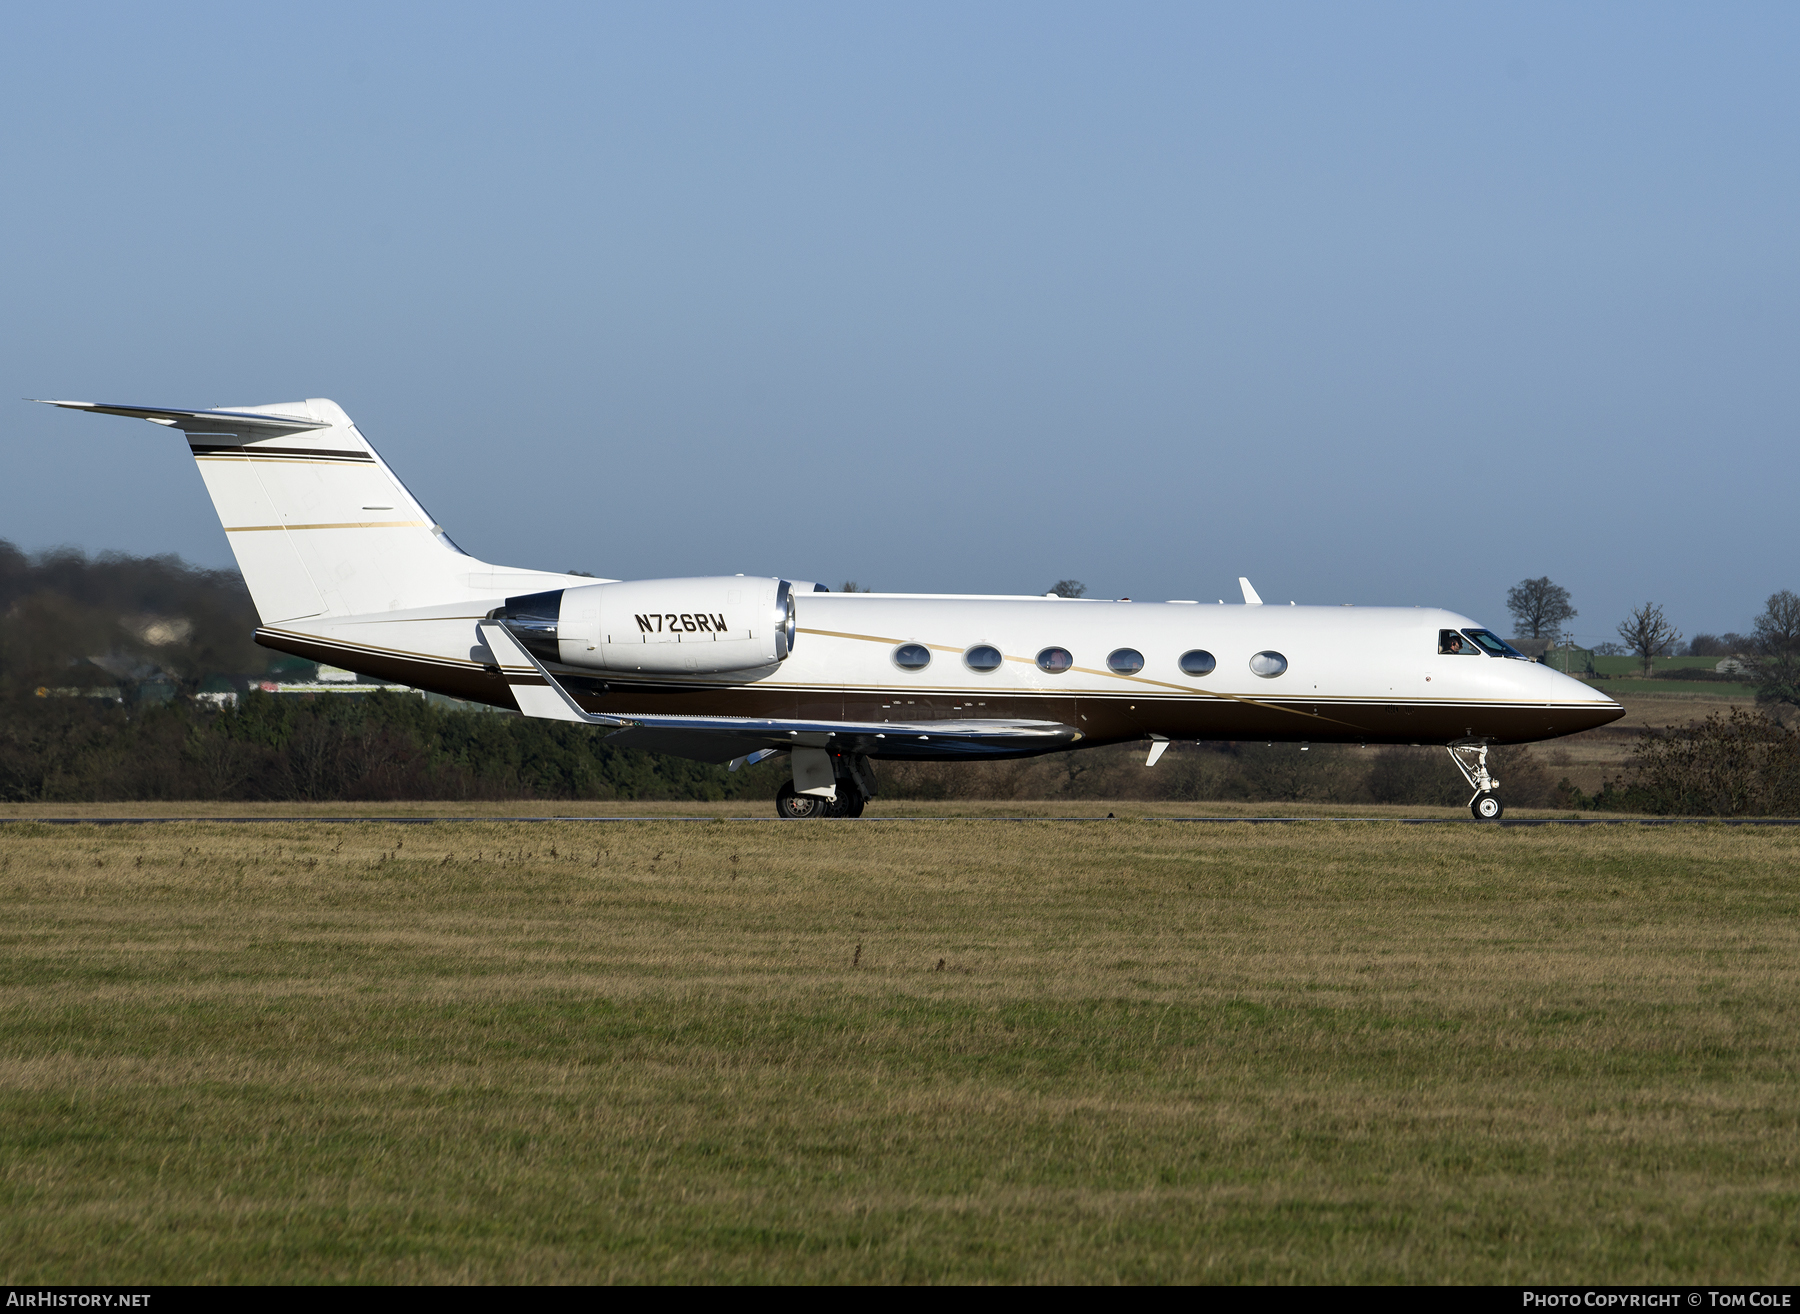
[0, 4, 1800, 639]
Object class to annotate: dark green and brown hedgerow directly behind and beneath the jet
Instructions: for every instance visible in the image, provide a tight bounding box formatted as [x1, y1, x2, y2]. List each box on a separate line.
[0, 689, 1577, 812]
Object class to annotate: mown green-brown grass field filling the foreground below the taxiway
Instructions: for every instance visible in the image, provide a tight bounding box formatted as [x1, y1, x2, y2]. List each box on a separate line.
[0, 817, 1800, 1283]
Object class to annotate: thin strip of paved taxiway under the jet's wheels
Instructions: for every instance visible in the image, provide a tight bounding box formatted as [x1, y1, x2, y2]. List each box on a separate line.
[0, 815, 1800, 826]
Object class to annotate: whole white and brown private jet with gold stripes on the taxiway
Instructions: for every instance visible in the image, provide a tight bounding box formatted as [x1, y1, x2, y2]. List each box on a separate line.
[38, 398, 1624, 819]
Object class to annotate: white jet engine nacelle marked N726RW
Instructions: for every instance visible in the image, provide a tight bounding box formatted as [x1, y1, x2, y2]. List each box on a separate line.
[488, 574, 794, 675]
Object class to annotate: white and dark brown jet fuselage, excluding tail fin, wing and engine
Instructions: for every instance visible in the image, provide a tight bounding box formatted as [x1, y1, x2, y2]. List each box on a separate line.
[265, 581, 1622, 743]
